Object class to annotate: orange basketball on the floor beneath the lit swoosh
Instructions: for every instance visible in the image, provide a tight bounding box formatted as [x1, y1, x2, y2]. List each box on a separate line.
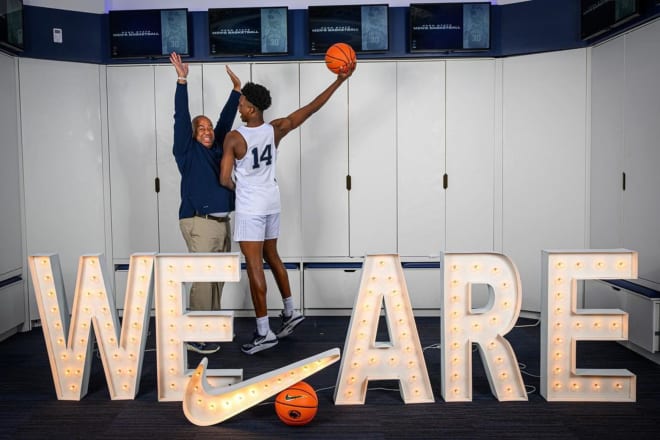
[275, 382, 319, 426]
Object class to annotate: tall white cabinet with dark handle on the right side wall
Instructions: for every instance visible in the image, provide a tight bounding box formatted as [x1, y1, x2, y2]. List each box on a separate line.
[591, 22, 660, 283]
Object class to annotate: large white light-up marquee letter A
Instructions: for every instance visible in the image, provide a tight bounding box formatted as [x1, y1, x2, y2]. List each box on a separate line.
[335, 255, 434, 405]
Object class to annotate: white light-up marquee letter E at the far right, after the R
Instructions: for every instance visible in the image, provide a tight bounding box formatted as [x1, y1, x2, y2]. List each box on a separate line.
[541, 249, 637, 402]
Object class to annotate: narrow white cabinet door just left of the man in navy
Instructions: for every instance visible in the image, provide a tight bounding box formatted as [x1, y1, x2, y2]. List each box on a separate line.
[107, 66, 159, 262]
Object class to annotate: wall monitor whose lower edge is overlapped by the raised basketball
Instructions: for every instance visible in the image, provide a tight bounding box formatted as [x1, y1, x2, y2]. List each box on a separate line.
[307, 4, 389, 54]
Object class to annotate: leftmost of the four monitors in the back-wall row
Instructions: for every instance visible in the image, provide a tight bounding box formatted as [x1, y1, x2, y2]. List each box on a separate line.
[108, 9, 190, 58]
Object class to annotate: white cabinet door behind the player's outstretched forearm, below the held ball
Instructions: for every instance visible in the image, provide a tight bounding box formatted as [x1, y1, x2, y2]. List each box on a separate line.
[299, 63, 353, 257]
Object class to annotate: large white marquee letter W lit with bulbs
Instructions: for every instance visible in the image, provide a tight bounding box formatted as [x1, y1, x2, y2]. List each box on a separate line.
[28, 254, 154, 400]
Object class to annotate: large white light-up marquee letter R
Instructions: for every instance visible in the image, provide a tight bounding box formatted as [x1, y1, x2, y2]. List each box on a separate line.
[440, 253, 527, 402]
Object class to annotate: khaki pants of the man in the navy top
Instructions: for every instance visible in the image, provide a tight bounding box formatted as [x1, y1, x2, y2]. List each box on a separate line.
[179, 217, 231, 310]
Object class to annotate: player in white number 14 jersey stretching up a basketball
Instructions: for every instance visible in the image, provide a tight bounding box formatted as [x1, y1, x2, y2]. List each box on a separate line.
[220, 63, 355, 354]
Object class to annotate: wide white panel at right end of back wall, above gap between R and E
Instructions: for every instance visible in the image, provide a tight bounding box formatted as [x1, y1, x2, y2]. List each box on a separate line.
[502, 49, 587, 311]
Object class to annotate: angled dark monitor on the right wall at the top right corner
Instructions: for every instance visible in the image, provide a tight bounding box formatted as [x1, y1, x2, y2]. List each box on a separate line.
[580, 0, 639, 40]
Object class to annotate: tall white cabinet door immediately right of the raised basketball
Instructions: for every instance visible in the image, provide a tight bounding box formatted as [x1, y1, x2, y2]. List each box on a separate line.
[348, 62, 397, 257]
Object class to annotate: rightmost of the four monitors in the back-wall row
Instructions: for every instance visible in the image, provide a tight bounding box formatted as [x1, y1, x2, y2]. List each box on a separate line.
[409, 2, 490, 52]
